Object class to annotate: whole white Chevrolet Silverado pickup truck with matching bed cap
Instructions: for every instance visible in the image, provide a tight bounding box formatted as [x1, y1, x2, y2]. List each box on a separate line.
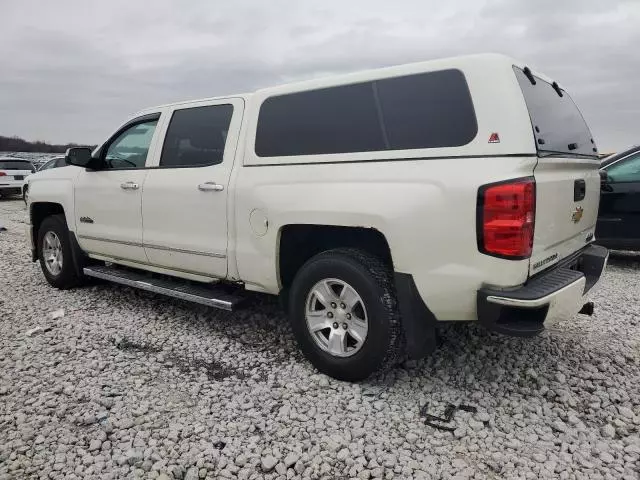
[29, 54, 608, 380]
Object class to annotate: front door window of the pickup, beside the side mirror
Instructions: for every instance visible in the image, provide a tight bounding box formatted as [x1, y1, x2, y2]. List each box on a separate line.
[104, 120, 158, 168]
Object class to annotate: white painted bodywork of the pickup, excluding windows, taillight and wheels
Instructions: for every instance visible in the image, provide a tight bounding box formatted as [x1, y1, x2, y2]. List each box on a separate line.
[30, 55, 599, 382]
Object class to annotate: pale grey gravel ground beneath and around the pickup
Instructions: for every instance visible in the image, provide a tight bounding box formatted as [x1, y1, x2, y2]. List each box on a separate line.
[0, 200, 640, 480]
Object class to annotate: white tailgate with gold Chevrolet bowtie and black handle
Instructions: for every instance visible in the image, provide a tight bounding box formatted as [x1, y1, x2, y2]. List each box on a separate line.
[529, 157, 600, 275]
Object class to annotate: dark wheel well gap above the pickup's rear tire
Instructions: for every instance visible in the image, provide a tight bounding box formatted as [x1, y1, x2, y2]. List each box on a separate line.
[278, 225, 393, 289]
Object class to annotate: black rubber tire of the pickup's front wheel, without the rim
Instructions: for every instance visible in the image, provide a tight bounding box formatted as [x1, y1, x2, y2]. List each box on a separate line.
[38, 215, 81, 290]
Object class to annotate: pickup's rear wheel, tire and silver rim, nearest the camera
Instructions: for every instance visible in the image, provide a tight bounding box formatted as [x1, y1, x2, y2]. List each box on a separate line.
[289, 249, 404, 381]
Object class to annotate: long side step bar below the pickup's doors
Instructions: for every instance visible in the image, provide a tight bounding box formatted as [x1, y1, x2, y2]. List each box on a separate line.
[83, 265, 242, 311]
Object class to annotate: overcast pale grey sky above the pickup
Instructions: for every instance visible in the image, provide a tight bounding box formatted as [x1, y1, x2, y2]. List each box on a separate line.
[0, 0, 640, 151]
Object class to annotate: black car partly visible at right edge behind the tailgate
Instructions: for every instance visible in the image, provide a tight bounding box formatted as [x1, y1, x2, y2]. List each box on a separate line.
[596, 145, 640, 250]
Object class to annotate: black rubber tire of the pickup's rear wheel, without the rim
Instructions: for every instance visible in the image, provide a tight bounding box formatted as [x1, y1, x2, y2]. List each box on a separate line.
[289, 248, 405, 382]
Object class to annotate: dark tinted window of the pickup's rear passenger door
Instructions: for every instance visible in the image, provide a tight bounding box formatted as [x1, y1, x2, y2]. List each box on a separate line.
[160, 105, 233, 167]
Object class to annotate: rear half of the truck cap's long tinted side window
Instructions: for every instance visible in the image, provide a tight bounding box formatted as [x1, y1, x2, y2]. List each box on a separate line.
[376, 70, 478, 150]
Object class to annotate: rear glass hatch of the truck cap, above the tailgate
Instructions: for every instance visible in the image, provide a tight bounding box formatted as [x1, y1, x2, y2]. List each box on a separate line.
[513, 67, 597, 158]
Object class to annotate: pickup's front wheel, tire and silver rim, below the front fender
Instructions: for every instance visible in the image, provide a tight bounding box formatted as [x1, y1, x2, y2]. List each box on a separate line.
[38, 215, 80, 289]
